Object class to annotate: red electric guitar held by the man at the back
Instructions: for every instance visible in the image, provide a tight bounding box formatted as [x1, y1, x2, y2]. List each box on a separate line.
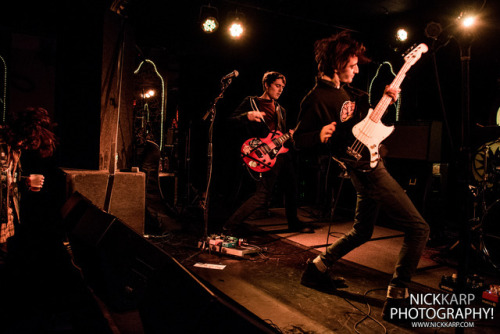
[241, 131, 292, 173]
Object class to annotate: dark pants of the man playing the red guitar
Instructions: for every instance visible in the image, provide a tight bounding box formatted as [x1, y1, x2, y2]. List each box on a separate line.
[224, 152, 298, 229]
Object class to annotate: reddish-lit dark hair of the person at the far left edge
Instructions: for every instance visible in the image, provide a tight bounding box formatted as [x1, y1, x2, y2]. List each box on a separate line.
[9, 107, 57, 158]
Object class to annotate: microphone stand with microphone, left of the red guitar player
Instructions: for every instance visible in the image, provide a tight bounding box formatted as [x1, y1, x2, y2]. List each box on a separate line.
[202, 78, 232, 243]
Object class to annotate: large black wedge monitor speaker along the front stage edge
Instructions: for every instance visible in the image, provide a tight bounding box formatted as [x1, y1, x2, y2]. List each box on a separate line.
[63, 193, 277, 334]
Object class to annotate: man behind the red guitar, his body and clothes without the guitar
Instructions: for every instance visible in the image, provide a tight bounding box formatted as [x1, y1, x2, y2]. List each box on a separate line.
[223, 72, 313, 236]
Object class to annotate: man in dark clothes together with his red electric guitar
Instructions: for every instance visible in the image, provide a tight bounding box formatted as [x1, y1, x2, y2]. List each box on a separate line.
[223, 72, 313, 237]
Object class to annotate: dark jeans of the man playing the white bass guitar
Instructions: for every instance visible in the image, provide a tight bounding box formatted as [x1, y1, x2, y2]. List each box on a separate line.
[320, 162, 429, 284]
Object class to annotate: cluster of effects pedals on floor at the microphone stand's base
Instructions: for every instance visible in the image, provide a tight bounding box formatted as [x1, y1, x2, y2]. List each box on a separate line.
[198, 235, 260, 257]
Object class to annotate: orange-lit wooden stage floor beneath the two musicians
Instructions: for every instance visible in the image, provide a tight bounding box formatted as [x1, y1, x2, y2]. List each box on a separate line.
[173, 208, 500, 333]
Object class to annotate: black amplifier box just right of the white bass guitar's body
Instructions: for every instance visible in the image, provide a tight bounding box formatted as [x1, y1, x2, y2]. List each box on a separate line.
[383, 121, 443, 162]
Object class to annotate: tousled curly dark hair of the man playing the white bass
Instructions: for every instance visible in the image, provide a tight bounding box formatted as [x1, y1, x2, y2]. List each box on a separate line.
[314, 30, 370, 77]
